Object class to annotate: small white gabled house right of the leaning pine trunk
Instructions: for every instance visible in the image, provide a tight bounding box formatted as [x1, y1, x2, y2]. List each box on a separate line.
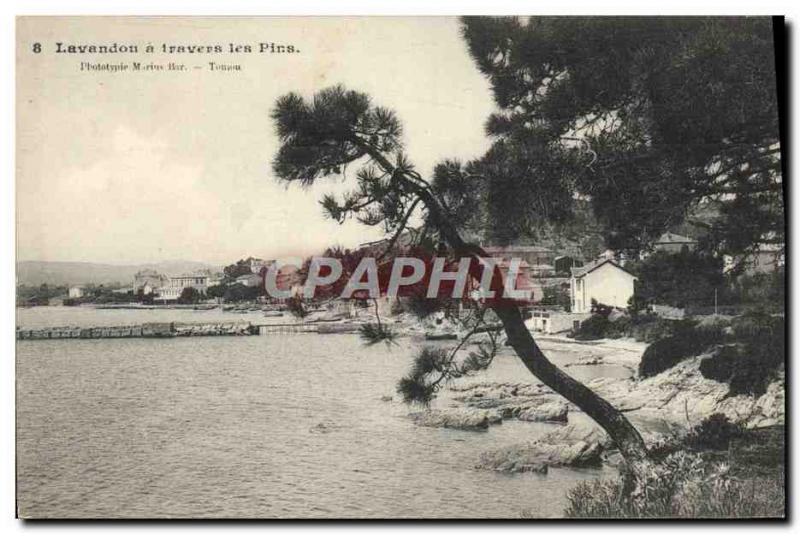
[569, 258, 636, 313]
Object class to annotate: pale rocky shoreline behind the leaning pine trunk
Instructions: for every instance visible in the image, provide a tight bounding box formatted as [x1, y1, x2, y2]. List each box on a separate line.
[404, 337, 785, 474]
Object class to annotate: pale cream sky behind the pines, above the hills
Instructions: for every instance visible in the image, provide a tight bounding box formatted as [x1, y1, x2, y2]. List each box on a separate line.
[16, 17, 493, 265]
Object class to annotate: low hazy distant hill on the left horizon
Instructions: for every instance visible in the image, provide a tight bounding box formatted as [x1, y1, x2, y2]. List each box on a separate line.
[17, 261, 221, 286]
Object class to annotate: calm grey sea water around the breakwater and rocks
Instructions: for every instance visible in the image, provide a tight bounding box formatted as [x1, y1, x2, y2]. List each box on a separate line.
[16, 308, 626, 518]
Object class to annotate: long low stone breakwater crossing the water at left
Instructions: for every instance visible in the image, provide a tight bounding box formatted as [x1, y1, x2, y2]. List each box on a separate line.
[16, 322, 258, 340]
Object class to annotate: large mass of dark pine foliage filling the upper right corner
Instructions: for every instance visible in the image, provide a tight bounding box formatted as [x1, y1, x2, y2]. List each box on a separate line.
[456, 17, 783, 254]
